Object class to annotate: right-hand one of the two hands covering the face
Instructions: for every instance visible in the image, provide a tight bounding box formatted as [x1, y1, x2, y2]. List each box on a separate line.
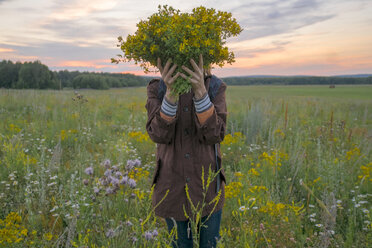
[180, 54, 207, 99]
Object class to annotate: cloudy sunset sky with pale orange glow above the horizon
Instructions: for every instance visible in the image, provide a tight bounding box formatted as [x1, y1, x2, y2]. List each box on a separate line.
[0, 0, 372, 77]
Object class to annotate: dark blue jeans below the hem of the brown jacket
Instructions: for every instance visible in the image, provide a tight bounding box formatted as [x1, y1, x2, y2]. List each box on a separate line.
[165, 209, 222, 248]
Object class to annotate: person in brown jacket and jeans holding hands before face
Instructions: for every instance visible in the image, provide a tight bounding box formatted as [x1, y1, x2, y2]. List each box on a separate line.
[146, 55, 227, 248]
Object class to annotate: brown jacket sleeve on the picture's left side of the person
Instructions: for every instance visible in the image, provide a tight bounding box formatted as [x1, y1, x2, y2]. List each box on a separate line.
[146, 80, 177, 144]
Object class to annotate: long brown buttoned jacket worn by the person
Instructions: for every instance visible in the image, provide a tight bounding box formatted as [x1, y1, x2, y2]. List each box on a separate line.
[146, 75, 227, 221]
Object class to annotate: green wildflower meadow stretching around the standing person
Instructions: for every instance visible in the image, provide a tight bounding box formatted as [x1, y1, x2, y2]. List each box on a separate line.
[0, 85, 372, 248]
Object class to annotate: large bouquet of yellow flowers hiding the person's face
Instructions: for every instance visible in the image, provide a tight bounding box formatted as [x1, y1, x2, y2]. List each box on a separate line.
[112, 5, 242, 95]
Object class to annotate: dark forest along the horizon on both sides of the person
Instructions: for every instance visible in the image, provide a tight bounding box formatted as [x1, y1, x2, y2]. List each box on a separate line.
[0, 60, 372, 89]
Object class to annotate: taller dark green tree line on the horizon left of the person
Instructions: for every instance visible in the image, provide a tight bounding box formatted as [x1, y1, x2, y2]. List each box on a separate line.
[0, 60, 148, 89]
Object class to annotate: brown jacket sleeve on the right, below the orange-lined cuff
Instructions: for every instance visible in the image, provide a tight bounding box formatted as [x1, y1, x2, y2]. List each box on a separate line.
[194, 83, 227, 145]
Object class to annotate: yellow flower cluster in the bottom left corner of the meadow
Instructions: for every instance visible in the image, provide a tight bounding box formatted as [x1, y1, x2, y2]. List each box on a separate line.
[0, 212, 28, 244]
